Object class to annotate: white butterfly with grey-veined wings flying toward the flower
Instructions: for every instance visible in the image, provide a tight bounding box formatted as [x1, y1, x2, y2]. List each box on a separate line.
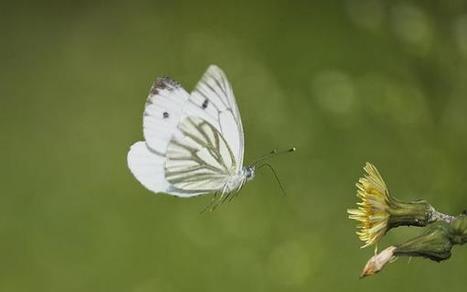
[127, 65, 295, 209]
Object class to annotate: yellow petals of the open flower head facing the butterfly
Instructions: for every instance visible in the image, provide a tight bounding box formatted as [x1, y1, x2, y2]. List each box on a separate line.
[347, 162, 391, 248]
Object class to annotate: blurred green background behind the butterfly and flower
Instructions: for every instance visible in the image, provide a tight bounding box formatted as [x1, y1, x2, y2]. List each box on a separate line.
[0, 0, 467, 292]
